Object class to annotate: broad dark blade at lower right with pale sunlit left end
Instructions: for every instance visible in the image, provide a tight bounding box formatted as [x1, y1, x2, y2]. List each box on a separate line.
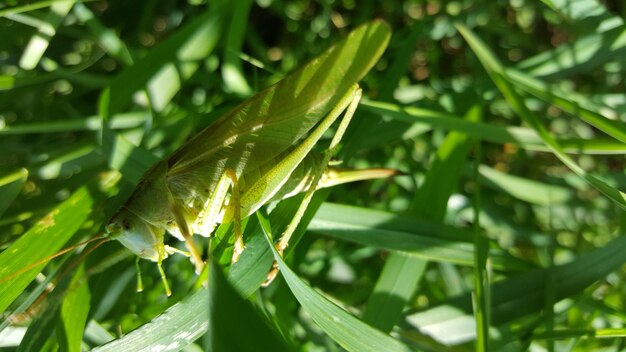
[406, 236, 626, 345]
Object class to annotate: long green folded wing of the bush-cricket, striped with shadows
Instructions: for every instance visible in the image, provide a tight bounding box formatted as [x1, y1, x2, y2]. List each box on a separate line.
[168, 21, 390, 192]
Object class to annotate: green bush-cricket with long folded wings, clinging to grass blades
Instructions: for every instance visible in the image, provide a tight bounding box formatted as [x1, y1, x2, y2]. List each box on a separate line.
[106, 21, 391, 282]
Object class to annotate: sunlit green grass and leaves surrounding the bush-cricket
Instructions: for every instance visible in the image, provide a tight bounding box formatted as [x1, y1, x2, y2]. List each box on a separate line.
[0, 0, 626, 351]
